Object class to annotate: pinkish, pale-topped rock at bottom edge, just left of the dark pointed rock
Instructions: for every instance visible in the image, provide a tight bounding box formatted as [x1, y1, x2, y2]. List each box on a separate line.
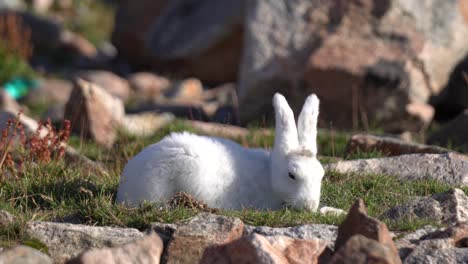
[200, 234, 326, 263]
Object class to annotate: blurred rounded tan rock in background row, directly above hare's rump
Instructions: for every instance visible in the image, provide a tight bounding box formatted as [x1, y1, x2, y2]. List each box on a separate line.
[127, 72, 171, 101]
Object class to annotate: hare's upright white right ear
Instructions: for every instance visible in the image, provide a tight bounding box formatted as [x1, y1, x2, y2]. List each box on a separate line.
[297, 94, 319, 155]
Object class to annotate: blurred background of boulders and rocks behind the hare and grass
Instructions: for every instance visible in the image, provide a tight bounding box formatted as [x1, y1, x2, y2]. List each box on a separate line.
[0, 0, 468, 151]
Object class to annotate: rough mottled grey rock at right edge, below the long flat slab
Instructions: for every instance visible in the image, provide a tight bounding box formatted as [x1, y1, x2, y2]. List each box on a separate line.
[382, 189, 468, 224]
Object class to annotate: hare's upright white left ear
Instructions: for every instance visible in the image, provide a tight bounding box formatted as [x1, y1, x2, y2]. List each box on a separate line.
[273, 93, 298, 152]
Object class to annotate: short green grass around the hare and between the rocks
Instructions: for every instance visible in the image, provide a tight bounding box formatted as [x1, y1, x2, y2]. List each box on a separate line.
[0, 120, 468, 246]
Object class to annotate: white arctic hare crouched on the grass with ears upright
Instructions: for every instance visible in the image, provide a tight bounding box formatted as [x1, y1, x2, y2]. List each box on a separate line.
[117, 93, 324, 211]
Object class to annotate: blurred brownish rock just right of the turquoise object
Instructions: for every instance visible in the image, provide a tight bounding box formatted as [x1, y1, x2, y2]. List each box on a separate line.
[24, 79, 73, 105]
